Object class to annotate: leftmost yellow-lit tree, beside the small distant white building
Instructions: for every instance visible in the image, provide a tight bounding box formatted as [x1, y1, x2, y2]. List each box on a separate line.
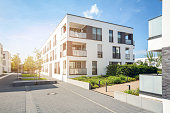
[11, 54, 21, 72]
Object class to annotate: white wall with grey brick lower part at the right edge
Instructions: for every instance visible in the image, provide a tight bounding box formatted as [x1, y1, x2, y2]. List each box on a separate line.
[162, 0, 170, 100]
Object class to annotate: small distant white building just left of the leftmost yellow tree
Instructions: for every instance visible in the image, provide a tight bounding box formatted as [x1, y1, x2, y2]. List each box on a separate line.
[2, 51, 11, 73]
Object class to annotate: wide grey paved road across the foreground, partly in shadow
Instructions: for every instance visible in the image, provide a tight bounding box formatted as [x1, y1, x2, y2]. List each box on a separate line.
[0, 75, 151, 113]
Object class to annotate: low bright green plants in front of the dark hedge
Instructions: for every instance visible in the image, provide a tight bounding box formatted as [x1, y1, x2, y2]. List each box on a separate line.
[72, 75, 136, 89]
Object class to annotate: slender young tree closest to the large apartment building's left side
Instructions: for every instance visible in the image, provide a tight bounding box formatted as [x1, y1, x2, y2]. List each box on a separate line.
[34, 49, 43, 78]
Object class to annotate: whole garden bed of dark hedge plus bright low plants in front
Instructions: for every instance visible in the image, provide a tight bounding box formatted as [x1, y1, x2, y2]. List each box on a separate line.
[72, 64, 157, 89]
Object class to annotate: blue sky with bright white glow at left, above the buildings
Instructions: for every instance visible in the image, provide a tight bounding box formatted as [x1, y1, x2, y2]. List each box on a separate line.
[0, 0, 162, 61]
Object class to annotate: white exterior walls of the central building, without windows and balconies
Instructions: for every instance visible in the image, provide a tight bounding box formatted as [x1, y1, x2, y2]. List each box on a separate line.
[41, 14, 134, 81]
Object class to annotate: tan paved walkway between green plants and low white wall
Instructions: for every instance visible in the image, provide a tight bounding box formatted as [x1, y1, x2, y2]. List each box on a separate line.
[94, 81, 139, 97]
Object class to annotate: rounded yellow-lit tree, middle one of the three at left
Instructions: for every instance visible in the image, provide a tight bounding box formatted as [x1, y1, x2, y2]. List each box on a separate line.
[24, 56, 35, 74]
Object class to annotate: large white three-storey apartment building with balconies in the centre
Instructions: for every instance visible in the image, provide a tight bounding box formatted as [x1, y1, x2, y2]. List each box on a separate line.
[41, 14, 134, 81]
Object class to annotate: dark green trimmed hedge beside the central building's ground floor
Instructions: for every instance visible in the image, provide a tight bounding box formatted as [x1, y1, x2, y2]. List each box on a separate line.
[106, 64, 158, 77]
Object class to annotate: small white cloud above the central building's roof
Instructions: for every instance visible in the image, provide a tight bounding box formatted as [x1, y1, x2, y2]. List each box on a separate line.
[83, 4, 101, 18]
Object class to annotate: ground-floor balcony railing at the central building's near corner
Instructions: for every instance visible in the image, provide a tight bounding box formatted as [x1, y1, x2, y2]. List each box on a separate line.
[69, 68, 87, 75]
